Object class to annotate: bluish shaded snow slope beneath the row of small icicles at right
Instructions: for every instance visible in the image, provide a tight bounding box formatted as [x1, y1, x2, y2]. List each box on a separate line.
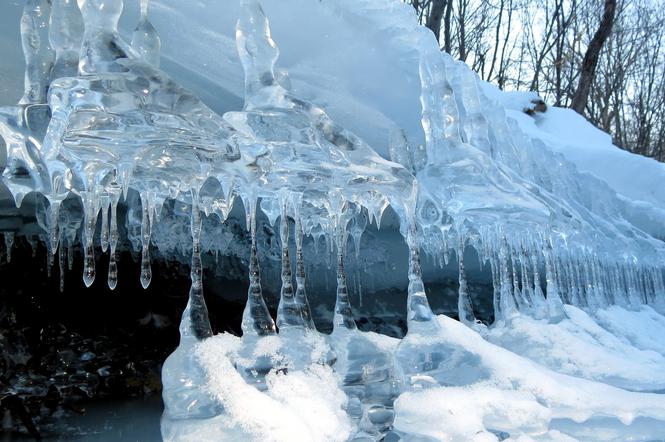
[487, 305, 665, 391]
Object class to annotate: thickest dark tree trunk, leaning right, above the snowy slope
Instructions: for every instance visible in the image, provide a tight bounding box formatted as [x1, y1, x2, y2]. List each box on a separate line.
[570, 0, 617, 115]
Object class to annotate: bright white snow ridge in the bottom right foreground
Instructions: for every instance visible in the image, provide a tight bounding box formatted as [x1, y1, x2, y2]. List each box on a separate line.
[395, 316, 665, 440]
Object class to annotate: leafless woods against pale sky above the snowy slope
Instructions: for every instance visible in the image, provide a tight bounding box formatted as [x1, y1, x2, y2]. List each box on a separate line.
[404, 0, 665, 161]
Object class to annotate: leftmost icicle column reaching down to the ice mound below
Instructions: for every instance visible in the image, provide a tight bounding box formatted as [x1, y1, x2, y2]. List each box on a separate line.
[180, 191, 212, 344]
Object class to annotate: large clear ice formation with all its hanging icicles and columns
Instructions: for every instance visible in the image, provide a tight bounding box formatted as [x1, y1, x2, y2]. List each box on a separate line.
[0, 0, 665, 440]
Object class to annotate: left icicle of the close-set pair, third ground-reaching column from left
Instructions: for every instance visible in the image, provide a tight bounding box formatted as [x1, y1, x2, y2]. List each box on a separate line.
[276, 197, 305, 330]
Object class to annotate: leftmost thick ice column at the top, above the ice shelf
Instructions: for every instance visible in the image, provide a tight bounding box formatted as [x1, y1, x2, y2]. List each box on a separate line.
[19, 0, 55, 105]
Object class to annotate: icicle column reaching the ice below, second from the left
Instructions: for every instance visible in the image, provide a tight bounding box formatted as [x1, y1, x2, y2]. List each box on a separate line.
[242, 198, 275, 336]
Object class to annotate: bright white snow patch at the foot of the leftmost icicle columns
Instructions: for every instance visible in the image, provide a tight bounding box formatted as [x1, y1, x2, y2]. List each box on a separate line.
[195, 334, 351, 442]
